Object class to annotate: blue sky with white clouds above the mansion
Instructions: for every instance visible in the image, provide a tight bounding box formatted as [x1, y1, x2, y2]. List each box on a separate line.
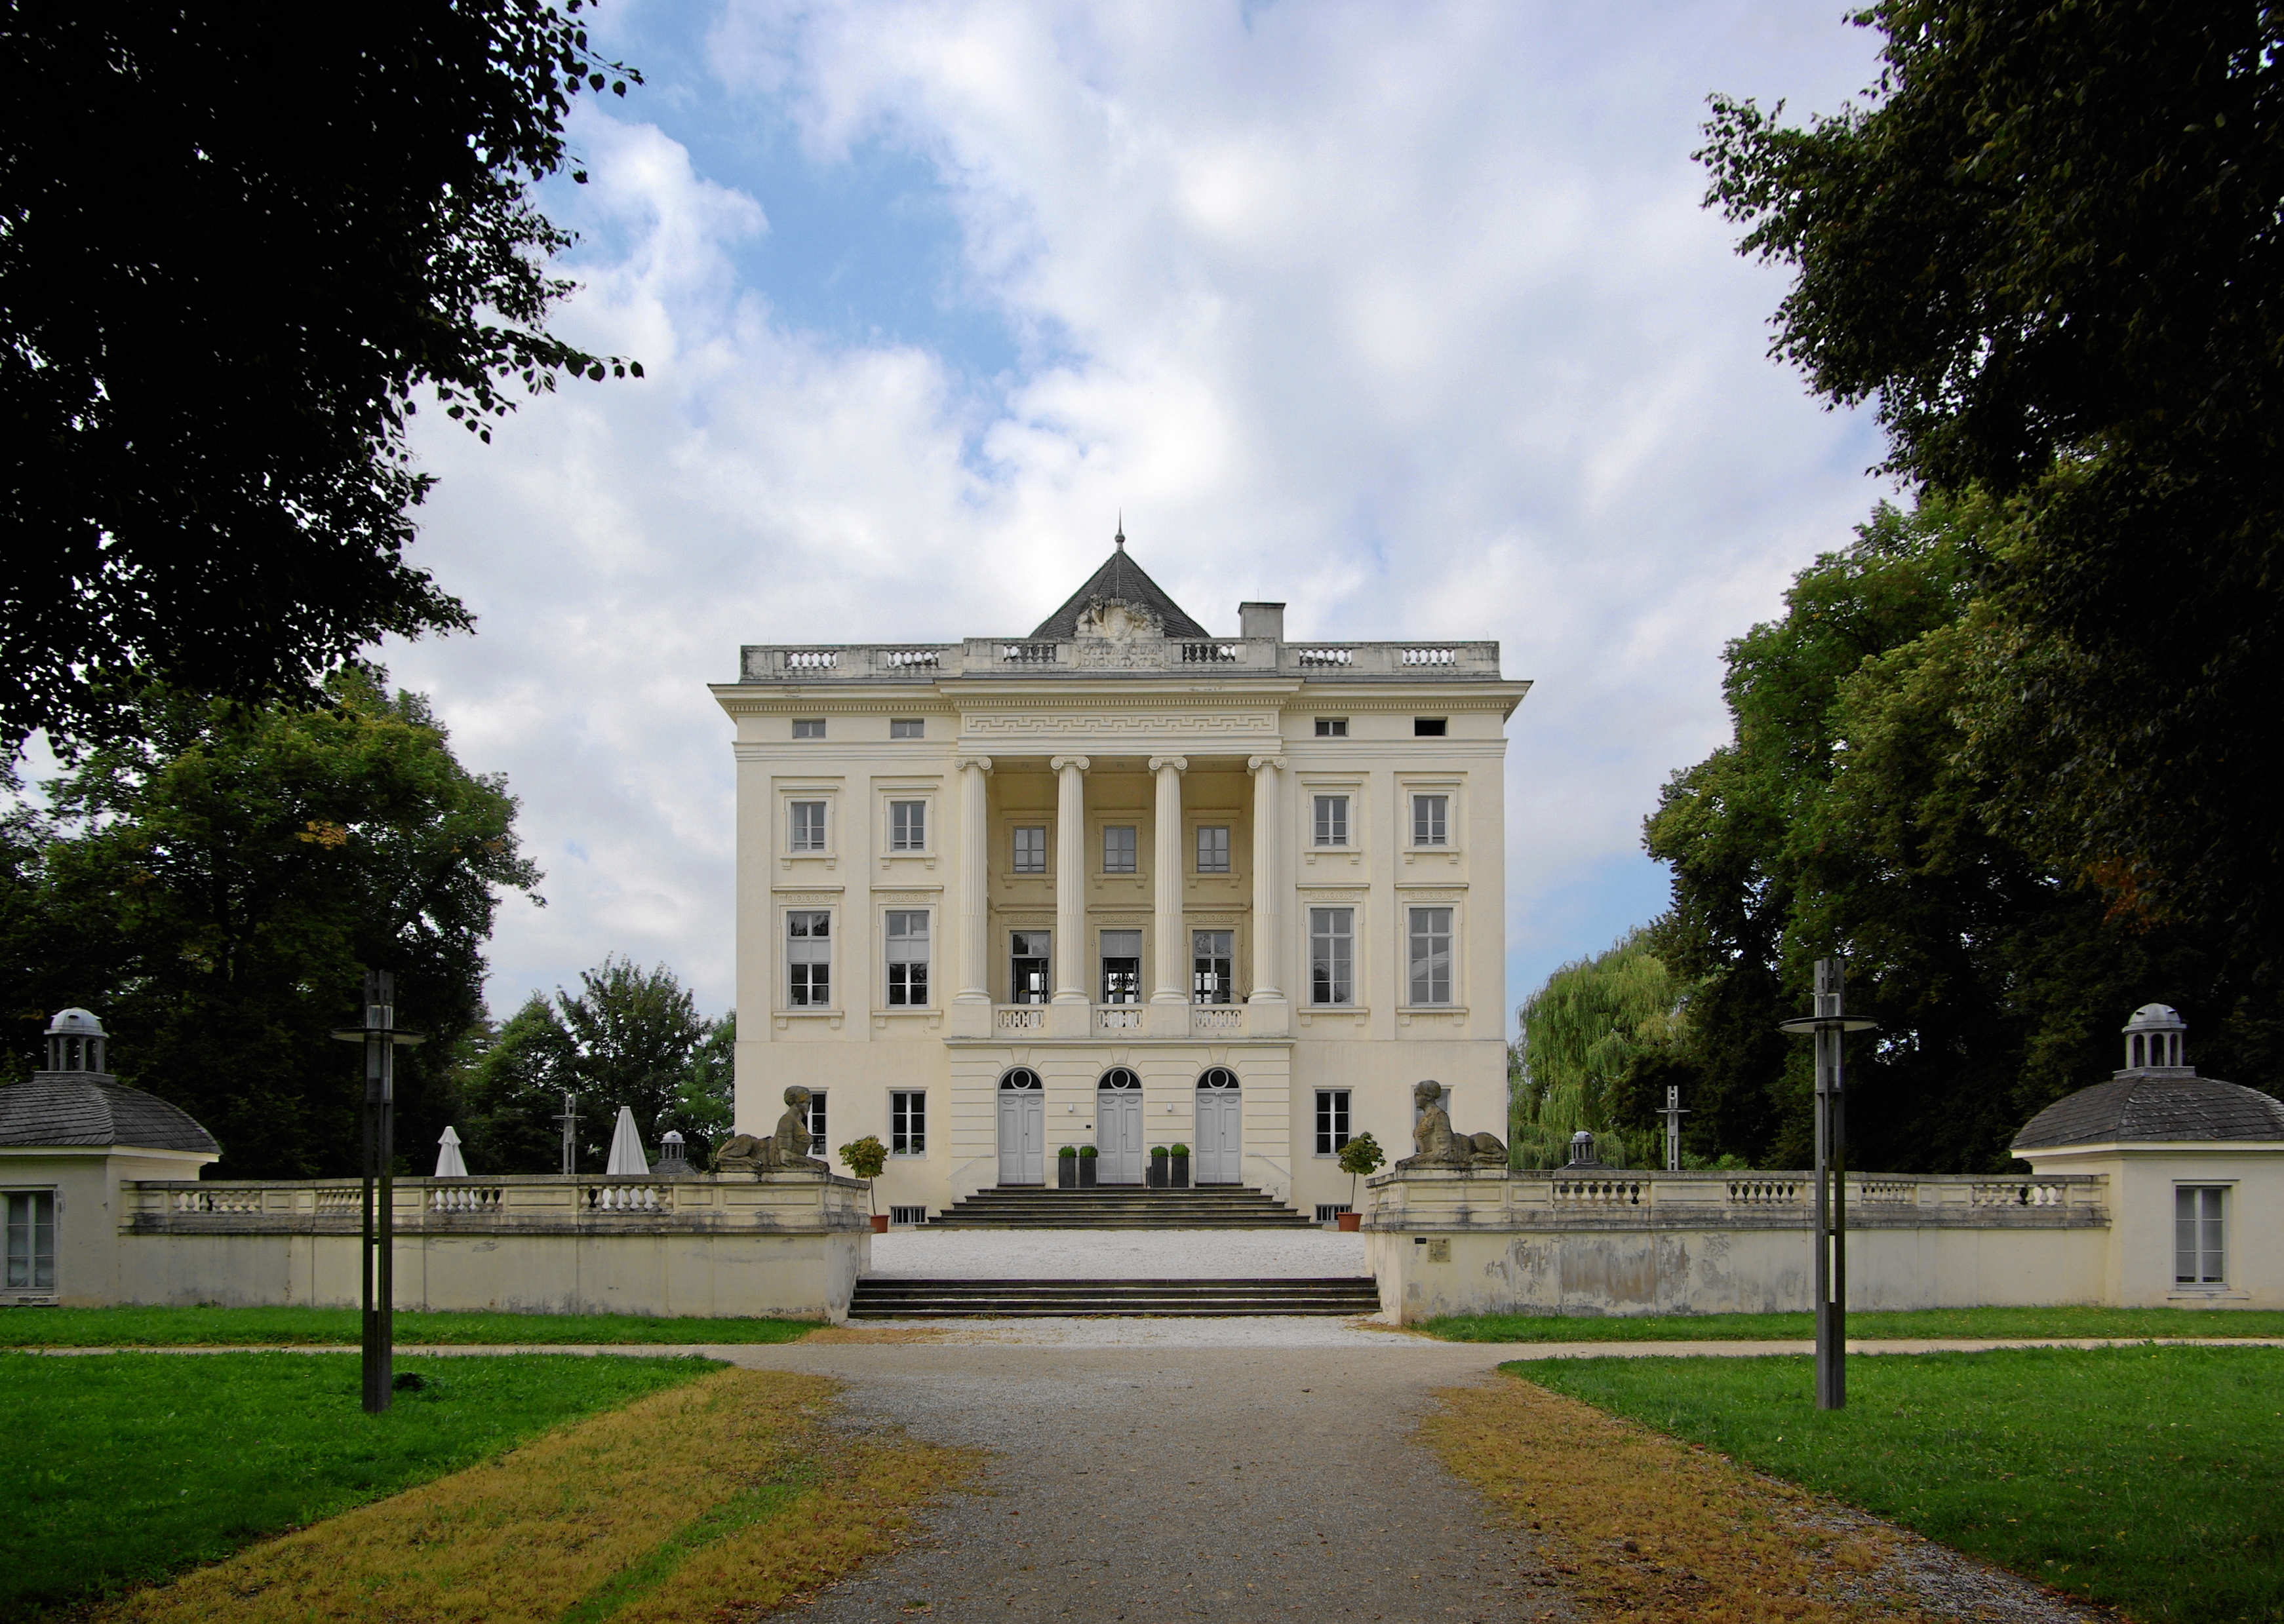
[386, 0, 1884, 1014]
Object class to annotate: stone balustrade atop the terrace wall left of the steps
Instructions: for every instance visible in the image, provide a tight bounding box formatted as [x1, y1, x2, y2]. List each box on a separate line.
[119, 1172, 870, 1236]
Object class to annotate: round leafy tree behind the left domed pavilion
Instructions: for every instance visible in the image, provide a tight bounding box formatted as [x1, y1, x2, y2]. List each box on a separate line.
[22, 667, 539, 1178]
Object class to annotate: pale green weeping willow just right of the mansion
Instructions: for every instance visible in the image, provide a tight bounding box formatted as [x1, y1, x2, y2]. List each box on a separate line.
[1510, 927, 1688, 1167]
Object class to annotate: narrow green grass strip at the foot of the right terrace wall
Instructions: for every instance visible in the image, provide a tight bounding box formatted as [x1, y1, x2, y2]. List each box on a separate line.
[1411, 1309, 2284, 1343]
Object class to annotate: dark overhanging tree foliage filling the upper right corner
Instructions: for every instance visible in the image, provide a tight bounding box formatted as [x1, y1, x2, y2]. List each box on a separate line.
[1699, 0, 2284, 980]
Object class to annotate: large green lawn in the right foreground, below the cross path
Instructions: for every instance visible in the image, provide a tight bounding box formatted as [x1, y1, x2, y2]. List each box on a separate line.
[1501, 1347, 2284, 1624]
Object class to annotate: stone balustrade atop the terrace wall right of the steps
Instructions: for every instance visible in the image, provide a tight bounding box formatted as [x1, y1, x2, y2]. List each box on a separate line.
[1364, 1167, 2110, 1231]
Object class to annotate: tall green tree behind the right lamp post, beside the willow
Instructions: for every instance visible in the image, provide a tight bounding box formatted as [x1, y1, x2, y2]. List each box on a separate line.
[1653, 495, 2279, 1172]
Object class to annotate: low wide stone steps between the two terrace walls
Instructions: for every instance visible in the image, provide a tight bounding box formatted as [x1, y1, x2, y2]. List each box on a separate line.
[850, 1275, 1379, 1320]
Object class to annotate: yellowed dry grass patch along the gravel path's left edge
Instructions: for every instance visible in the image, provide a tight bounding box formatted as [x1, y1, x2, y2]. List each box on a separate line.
[114, 1370, 973, 1624]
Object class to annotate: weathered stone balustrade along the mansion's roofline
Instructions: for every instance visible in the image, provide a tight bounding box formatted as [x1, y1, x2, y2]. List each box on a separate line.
[738, 637, 1499, 683]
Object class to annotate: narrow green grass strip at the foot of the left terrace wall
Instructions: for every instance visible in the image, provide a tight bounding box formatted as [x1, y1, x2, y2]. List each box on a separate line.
[0, 1309, 817, 1347]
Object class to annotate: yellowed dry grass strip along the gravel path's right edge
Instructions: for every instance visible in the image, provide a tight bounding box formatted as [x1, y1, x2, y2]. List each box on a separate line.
[1421, 1378, 1919, 1624]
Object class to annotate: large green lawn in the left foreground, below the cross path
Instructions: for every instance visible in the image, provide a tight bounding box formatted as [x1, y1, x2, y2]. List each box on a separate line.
[0, 1352, 722, 1619]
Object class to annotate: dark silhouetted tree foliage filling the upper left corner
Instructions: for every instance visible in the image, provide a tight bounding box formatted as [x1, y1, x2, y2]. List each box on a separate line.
[0, 0, 640, 754]
